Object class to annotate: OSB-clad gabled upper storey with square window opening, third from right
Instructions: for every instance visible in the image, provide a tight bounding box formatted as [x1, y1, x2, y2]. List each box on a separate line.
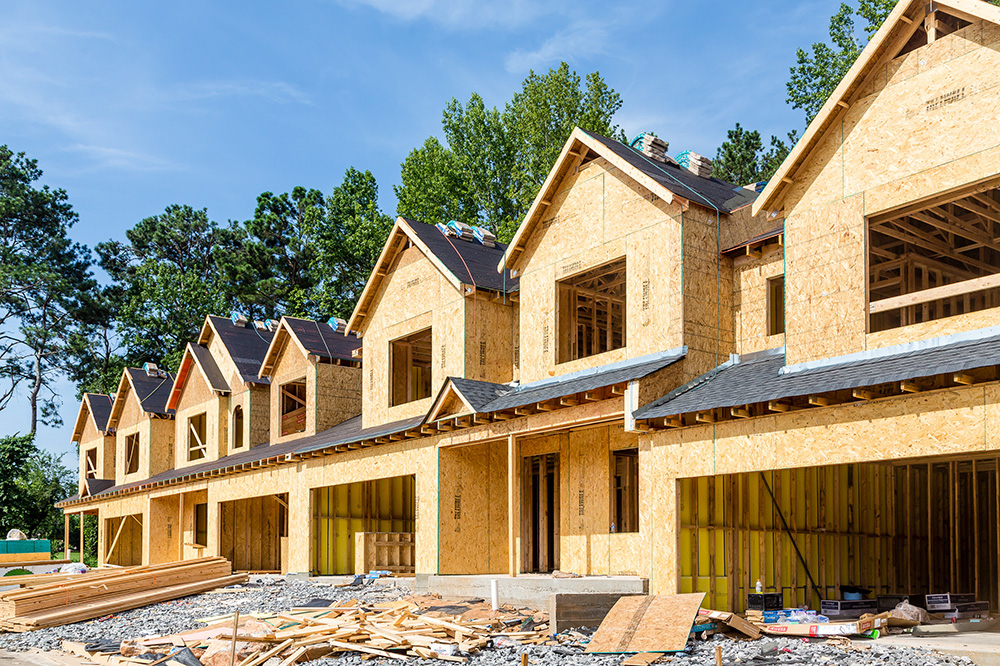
[348, 217, 518, 427]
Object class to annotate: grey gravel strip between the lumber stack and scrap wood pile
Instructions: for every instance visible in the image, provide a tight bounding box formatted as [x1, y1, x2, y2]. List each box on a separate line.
[0, 577, 409, 652]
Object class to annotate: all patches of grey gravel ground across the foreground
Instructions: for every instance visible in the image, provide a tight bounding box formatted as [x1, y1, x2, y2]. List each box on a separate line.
[0, 578, 973, 666]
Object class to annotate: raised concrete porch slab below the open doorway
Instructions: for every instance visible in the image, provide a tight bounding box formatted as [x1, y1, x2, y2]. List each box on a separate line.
[428, 574, 649, 610]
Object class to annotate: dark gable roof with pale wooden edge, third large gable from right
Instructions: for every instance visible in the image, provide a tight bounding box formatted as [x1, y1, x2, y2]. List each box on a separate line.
[347, 217, 518, 332]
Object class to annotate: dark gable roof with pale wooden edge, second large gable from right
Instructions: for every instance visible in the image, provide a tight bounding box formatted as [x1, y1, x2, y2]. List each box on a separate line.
[499, 127, 757, 268]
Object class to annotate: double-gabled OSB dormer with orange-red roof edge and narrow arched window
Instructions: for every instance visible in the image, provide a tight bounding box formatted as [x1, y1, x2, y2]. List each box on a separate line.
[167, 315, 274, 468]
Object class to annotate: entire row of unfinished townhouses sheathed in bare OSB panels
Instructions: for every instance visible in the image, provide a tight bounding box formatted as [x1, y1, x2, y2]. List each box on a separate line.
[59, 0, 1000, 610]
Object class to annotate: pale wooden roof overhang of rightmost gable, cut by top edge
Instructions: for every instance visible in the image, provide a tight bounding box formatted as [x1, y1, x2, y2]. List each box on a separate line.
[753, 0, 1000, 215]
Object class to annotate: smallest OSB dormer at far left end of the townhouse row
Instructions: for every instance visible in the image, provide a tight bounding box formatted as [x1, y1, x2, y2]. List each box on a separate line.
[73, 393, 115, 497]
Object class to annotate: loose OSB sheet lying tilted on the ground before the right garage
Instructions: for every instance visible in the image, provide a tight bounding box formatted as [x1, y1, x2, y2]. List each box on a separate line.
[587, 592, 705, 653]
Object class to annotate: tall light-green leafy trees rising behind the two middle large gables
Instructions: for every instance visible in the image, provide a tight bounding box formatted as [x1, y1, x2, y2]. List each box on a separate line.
[396, 62, 625, 241]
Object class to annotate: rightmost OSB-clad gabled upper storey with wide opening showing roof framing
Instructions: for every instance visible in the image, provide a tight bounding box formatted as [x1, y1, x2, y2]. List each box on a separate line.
[754, 0, 1000, 365]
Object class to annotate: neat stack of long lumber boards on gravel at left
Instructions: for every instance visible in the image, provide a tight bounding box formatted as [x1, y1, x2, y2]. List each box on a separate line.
[0, 557, 247, 631]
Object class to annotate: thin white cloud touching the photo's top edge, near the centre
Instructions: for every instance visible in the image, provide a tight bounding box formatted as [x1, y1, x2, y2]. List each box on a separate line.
[340, 0, 554, 28]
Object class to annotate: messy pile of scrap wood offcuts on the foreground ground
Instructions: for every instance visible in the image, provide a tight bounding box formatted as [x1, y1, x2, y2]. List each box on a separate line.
[99, 599, 551, 666]
